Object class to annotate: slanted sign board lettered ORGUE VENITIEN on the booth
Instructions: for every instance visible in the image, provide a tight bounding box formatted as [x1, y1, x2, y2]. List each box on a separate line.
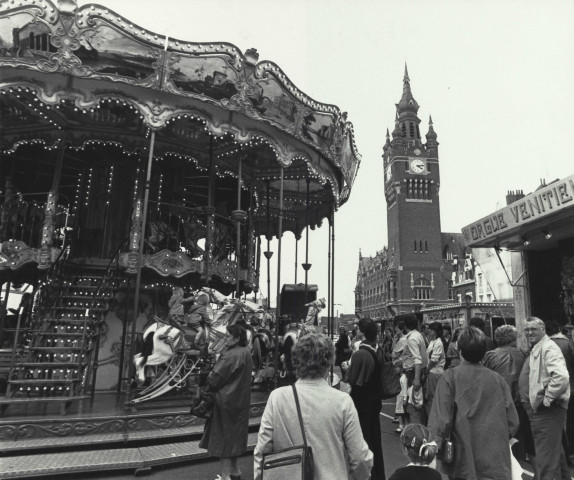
[462, 175, 574, 246]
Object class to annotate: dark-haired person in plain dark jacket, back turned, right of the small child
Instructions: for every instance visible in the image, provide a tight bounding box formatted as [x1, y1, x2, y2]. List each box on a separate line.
[428, 327, 518, 480]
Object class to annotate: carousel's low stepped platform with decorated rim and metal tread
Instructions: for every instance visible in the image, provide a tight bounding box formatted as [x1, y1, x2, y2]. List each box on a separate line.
[0, 391, 268, 479]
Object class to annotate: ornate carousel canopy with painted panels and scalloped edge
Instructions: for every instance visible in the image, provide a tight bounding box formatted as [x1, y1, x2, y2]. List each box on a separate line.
[0, 0, 360, 236]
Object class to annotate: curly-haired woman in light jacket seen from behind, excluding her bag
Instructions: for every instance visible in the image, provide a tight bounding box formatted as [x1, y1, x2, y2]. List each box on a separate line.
[254, 333, 373, 480]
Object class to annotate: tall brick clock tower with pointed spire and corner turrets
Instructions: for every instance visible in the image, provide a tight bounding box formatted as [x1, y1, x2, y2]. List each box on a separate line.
[383, 65, 448, 314]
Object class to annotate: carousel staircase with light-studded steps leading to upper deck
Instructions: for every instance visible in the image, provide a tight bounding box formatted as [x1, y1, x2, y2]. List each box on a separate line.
[0, 264, 113, 417]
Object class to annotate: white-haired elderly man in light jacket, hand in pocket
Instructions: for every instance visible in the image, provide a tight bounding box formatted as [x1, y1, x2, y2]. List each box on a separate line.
[524, 317, 570, 480]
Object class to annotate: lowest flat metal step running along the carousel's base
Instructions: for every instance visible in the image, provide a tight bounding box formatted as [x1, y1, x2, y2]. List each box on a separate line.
[0, 432, 257, 479]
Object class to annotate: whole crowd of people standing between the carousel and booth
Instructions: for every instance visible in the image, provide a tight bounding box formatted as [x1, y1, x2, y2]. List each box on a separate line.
[201, 315, 574, 480]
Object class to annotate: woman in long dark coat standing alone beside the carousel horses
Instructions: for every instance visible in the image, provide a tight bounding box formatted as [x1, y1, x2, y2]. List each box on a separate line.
[199, 325, 253, 480]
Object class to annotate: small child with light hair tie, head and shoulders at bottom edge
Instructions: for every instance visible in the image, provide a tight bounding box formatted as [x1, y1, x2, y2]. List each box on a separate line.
[389, 423, 442, 480]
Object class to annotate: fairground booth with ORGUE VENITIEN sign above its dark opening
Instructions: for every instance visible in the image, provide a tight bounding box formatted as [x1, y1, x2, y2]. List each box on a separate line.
[462, 175, 574, 347]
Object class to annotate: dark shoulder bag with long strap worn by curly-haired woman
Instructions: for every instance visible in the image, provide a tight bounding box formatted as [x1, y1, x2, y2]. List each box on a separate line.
[261, 385, 314, 480]
